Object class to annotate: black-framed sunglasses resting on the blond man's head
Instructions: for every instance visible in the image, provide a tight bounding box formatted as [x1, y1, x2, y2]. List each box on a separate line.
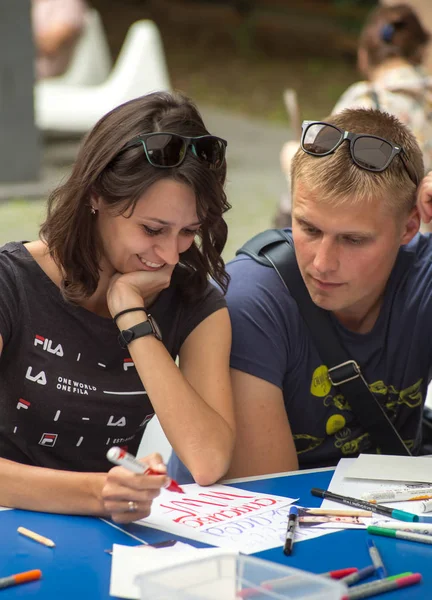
[301, 121, 419, 186]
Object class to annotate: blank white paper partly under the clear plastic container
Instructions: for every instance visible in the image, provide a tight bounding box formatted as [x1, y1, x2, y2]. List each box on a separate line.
[110, 542, 238, 600]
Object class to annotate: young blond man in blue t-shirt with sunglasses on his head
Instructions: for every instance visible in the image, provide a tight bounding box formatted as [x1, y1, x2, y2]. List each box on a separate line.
[221, 109, 432, 476]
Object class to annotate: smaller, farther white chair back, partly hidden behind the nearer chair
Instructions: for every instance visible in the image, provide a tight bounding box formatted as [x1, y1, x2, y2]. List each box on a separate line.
[44, 8, 112, 87]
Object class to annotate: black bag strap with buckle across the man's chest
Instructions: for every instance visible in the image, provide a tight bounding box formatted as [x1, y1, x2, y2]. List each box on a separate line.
[236, 229, 411, 456]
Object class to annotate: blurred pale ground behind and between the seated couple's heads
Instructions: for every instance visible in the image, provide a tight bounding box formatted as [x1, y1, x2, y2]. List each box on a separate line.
[0, 107, 289, 258]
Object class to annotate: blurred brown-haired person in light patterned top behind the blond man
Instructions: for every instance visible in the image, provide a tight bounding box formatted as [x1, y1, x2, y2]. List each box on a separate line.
[275, 4, 432, 227]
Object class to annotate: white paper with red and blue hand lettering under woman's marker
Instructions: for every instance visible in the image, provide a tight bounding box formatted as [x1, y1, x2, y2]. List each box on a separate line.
[137, 483, 331, 554]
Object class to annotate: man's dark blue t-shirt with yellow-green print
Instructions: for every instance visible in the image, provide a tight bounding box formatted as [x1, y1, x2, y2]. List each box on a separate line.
[170, 234, 432, 486]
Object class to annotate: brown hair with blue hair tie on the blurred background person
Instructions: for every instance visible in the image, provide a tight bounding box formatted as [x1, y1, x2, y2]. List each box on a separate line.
[359, 4, 430, 68]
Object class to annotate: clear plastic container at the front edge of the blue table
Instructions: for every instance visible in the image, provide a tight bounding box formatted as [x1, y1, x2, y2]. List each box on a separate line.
[135, 553, 347, 600]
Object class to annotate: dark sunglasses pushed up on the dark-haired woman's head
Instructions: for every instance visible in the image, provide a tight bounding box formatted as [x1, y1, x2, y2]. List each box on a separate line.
[122, 132, 228, 170]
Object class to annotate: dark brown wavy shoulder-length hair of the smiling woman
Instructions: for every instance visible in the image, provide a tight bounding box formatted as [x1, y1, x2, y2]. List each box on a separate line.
[40, 92, 231, 303]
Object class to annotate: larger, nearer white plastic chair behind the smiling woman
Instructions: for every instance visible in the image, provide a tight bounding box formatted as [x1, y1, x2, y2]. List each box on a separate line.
[35, 21, 171, 134]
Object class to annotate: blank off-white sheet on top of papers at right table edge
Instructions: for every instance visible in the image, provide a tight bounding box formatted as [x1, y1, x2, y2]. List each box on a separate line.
[342, 454, 432, 483]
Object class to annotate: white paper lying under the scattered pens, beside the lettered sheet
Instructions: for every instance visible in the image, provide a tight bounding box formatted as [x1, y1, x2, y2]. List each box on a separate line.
[321, 455, 426, 523]
